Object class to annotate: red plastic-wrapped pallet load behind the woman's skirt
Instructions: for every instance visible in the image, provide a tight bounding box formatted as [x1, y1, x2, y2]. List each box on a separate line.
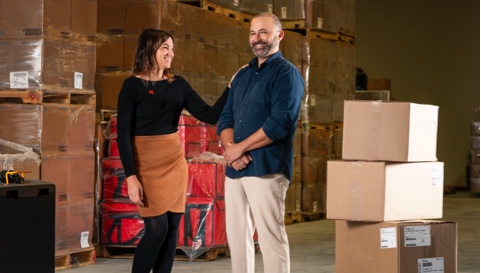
[100, 114, 227, 252]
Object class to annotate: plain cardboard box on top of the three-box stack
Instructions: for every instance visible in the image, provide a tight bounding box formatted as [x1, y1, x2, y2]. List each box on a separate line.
[342, 100, 439, 162]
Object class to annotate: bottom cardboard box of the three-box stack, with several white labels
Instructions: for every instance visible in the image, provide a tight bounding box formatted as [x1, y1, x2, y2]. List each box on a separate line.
[335, 221, 458, 273]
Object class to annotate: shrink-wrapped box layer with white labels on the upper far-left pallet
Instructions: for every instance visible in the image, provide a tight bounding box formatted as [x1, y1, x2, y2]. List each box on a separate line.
[0, 37, 96, 91]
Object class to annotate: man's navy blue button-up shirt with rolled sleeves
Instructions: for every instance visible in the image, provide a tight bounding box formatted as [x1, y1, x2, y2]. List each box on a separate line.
[217, 51, 304, 181]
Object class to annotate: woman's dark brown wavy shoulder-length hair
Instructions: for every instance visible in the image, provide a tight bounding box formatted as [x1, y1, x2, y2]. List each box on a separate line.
[132, 29, 174, 83]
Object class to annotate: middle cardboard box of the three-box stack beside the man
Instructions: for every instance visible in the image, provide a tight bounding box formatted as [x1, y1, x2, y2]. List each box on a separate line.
[326, 160, 444, 222]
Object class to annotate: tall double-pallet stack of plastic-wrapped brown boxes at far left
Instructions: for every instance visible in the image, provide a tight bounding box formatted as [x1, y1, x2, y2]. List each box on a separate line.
[0, 0, 97, 262]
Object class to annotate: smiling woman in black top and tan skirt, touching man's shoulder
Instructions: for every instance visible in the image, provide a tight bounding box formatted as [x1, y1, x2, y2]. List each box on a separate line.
[117, 29, 229, 273]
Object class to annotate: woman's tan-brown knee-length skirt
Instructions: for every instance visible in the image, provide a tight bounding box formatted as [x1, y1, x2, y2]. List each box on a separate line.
[133, 133, 189, 217]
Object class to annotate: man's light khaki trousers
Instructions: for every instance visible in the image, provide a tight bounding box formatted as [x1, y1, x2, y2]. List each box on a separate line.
[225, 174, 290, 273]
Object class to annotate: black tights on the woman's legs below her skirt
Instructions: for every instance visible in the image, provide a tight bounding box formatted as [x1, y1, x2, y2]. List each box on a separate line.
[132, 212, 182, 273]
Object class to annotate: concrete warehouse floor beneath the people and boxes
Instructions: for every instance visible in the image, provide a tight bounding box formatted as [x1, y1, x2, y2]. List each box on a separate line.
[62, 190, 480, 273]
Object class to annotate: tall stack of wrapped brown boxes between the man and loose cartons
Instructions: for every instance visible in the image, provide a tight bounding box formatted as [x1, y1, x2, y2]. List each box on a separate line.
[273, 0, 355, 219]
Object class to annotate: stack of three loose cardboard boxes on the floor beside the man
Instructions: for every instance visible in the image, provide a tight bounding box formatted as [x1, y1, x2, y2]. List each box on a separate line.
[327, 101, 457, 273]
